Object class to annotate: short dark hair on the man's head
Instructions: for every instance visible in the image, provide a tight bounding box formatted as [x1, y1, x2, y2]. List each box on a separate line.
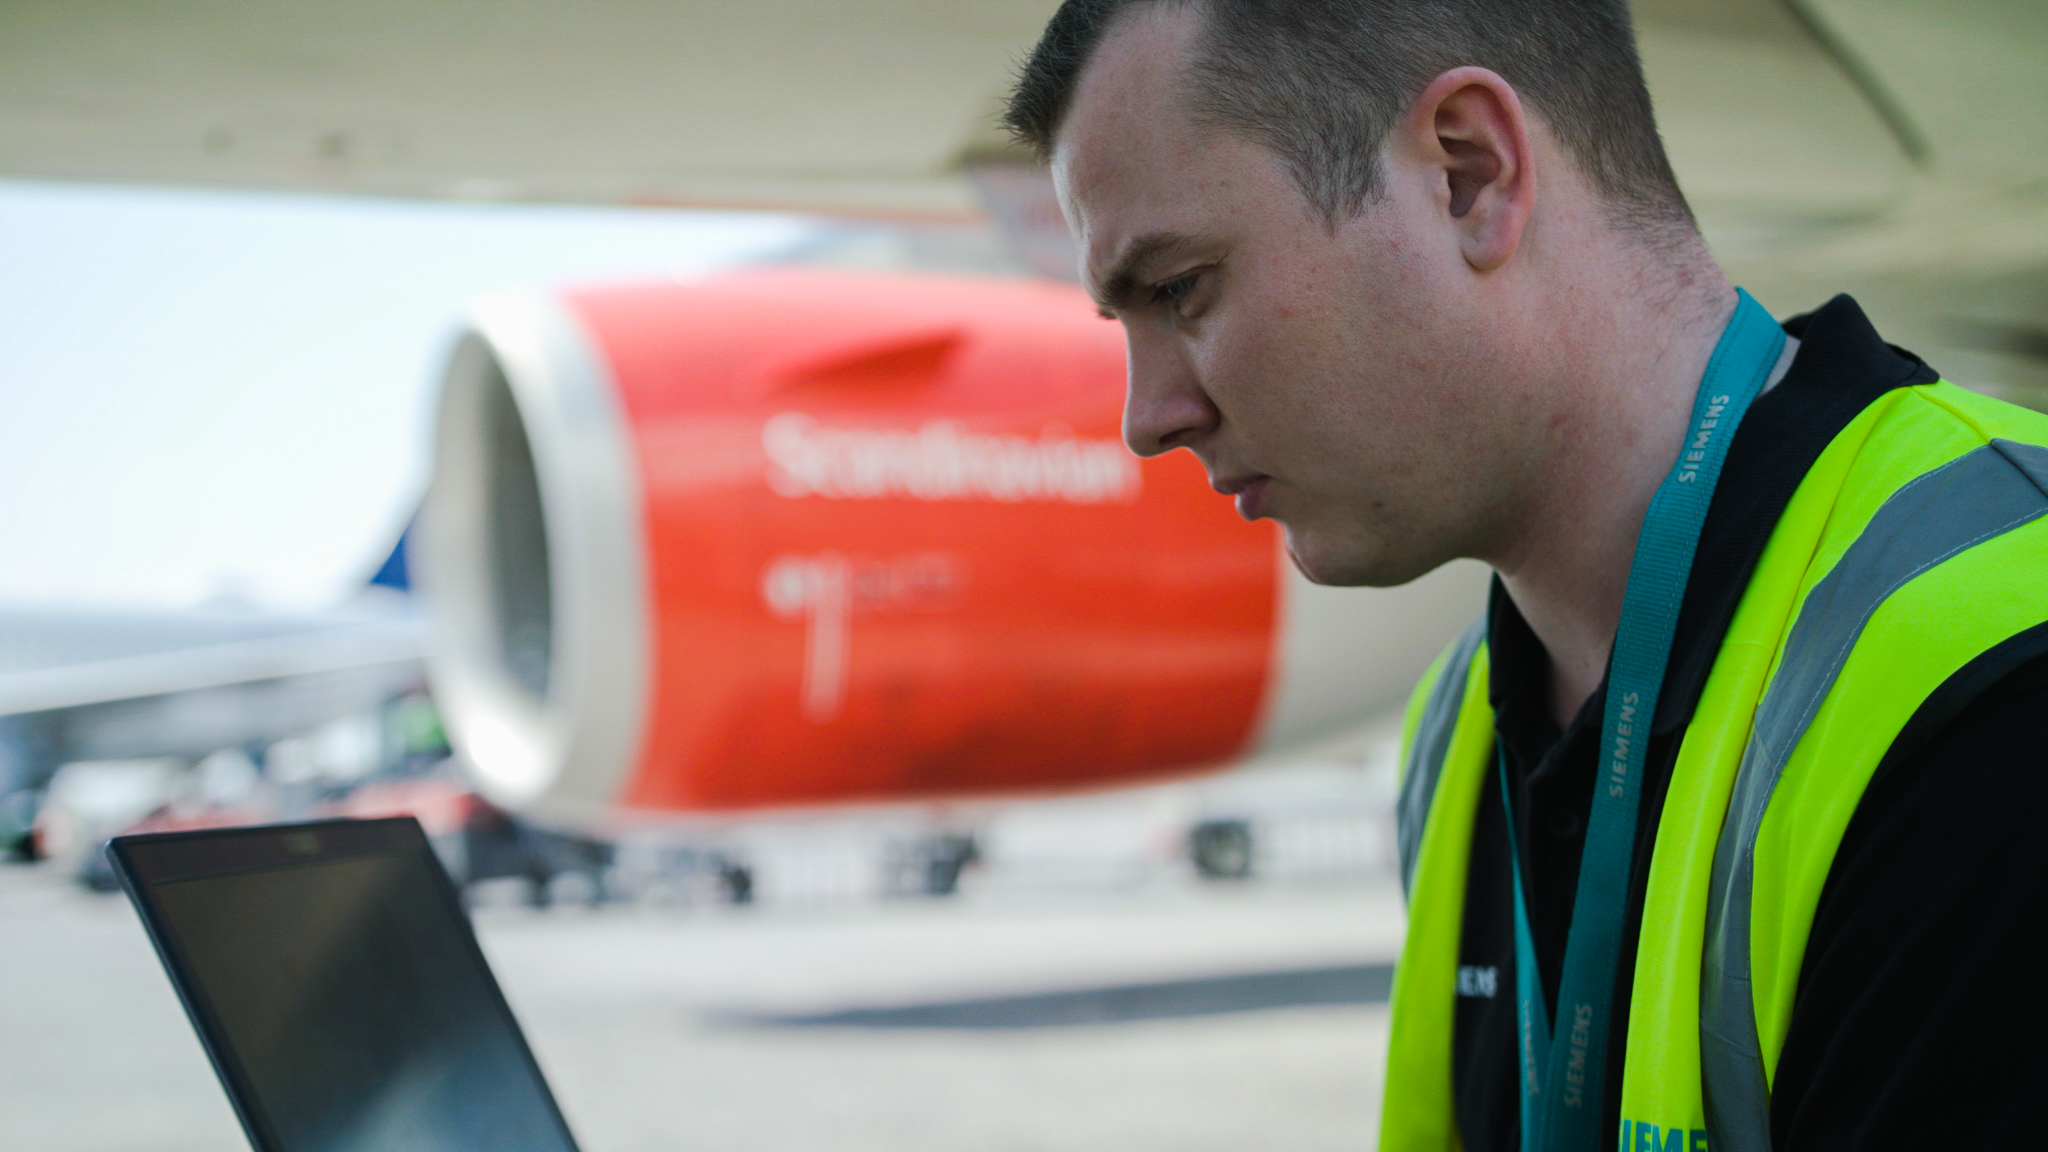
[1004, 0, 1696, 236]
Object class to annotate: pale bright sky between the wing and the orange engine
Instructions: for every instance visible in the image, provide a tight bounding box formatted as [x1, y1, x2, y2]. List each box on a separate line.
[0, 180, 817, 609]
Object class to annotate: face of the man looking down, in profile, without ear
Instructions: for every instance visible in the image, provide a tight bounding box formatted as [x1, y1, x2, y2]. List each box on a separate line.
[1053, 6, 1523, 584]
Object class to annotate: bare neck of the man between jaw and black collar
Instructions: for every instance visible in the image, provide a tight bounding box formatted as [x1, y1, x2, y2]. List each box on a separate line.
[1489, 260, 1735, 728]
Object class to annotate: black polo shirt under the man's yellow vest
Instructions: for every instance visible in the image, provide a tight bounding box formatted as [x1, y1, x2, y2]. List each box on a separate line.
[1454, 295, 2048, 1152]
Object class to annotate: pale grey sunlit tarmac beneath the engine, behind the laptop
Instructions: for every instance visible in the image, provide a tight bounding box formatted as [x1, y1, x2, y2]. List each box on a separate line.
[0, 844, 1403, 1152]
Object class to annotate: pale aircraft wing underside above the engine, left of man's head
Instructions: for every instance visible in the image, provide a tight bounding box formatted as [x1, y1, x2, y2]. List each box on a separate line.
[0, 0, 1055, 217]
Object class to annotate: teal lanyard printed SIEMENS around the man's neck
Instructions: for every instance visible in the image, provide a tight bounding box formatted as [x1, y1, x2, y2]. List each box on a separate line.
[1499, 289, 1786, 1152]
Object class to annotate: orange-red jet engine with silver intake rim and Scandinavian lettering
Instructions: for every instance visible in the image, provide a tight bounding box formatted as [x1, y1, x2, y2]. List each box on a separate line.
[422, 271, 1477, 818]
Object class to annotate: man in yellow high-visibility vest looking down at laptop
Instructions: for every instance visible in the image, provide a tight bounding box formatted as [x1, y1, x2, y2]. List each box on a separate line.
[1008, 0, 2048, 1152]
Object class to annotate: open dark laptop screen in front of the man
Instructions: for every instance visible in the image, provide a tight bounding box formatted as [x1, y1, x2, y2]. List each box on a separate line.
[106, 816, 575, 1152]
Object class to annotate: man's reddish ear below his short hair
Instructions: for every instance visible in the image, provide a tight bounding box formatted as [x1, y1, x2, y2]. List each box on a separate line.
[1403, 68, 1536, 273]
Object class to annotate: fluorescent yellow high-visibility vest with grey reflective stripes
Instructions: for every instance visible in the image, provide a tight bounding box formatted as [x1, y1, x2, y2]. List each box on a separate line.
[1380, 383, 2048, 1152]
